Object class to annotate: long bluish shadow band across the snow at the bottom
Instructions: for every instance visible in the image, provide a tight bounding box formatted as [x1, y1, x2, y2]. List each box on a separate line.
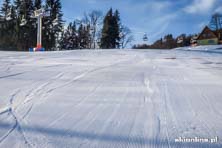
[0, 122, 219, 148]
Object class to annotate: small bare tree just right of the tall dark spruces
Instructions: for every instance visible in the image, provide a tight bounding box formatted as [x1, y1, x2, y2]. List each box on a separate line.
[120, 25, 134, 49]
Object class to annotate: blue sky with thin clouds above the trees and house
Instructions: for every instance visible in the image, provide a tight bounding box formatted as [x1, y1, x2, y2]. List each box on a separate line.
[62, 0, 222, 43]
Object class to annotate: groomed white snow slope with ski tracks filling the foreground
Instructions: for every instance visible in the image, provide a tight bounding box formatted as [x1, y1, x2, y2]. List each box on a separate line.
[0, 47, 222, 148]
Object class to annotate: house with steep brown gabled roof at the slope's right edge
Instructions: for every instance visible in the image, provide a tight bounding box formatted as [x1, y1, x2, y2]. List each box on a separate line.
[196, 26, 222, 45]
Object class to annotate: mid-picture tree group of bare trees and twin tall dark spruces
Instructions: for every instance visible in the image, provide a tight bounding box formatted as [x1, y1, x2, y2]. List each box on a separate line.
[60, 8, 133, 50]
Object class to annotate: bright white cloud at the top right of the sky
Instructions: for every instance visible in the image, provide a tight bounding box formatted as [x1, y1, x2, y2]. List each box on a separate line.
[184, 0, 216, 14]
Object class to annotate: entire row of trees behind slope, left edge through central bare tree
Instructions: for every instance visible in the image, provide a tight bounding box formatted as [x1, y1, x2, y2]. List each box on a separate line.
[0, 0, 133, 51]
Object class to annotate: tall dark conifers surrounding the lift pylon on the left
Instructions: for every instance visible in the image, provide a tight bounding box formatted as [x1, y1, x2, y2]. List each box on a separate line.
[0, 0, 64, 51]
